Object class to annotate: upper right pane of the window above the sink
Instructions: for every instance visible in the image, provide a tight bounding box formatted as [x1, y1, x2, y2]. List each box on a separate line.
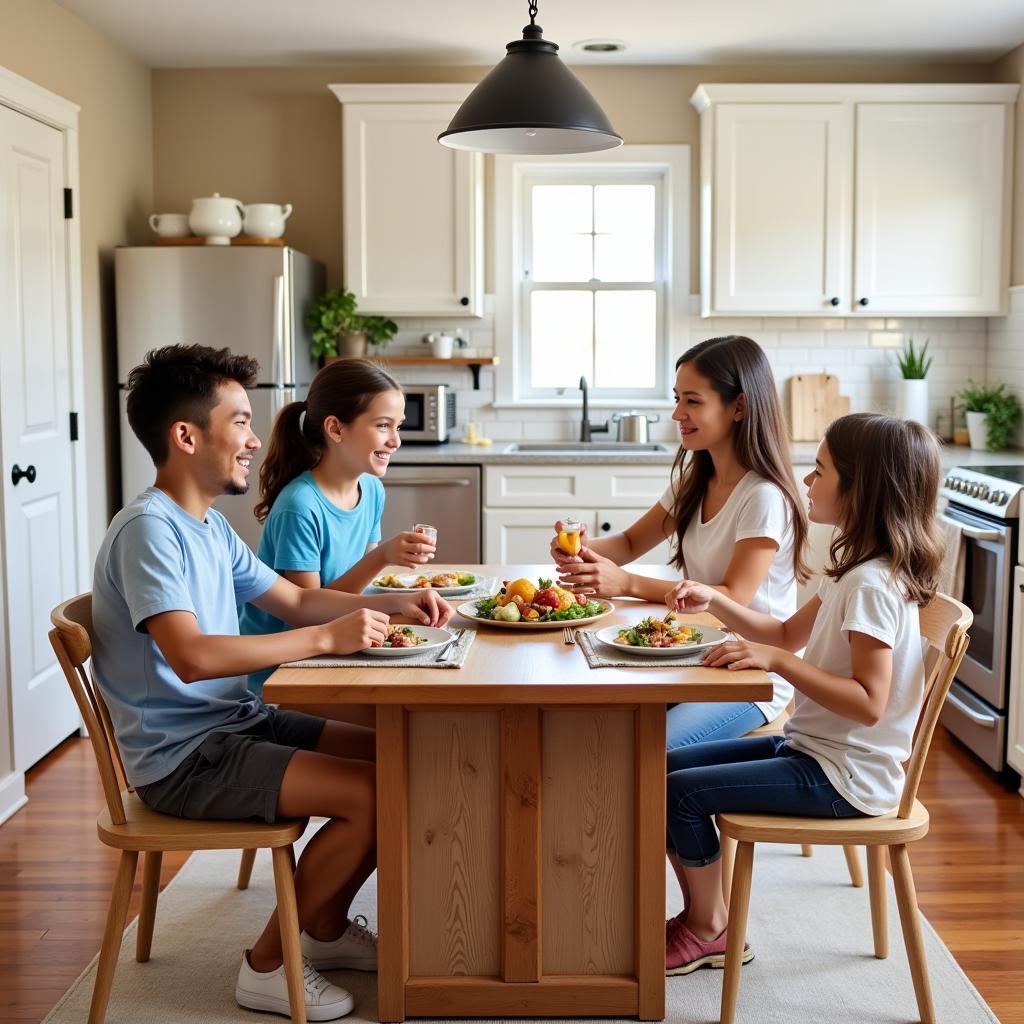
[594, 185, 655, 281]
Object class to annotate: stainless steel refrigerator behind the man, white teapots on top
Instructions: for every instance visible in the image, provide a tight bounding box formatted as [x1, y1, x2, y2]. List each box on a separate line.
[114, 246, 326, 550]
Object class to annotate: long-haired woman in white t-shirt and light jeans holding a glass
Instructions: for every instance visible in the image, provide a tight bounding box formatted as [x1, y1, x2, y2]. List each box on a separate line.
[551, 335, 807, 751]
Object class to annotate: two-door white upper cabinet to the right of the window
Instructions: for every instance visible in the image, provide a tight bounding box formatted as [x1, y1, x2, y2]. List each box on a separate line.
[692, 85, 1018, 316]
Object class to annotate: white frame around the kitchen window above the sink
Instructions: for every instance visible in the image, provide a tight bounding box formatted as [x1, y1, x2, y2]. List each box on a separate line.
[494, 145, 690, 409]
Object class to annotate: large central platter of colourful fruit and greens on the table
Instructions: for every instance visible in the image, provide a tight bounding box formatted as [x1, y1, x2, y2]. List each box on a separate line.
[456, 579, 615, 630]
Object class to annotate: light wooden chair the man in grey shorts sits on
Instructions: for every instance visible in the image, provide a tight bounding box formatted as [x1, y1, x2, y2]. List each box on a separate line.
[49, 594, 306, 1024]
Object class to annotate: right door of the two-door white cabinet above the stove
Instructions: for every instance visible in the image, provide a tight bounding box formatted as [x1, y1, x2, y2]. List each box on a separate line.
[854, 103, 1006, 316]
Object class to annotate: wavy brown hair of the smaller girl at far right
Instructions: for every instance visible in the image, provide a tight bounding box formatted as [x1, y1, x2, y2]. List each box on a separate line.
[824, 413, 942, 605]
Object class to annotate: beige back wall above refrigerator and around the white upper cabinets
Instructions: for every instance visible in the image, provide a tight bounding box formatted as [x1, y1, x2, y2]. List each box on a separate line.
[153, 62, 995, 292]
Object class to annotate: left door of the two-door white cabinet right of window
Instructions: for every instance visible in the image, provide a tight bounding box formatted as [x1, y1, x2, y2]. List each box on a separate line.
[701, 103, 852, 315]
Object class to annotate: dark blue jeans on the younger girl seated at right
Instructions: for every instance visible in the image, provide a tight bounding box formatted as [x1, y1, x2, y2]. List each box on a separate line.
[668, 736, 865, 867]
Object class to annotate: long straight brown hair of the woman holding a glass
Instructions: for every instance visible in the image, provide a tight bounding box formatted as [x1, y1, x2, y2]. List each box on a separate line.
[671, 334, 810, 583]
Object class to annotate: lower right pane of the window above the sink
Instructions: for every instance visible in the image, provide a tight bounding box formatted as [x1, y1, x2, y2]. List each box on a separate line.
[594, 291, 657, 388]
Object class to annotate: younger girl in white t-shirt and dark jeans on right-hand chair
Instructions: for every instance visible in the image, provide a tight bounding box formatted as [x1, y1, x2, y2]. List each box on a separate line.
[666, 413, 942, 974]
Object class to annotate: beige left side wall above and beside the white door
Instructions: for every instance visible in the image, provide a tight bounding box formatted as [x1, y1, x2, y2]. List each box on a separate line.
[0, 0, 153, 558]
